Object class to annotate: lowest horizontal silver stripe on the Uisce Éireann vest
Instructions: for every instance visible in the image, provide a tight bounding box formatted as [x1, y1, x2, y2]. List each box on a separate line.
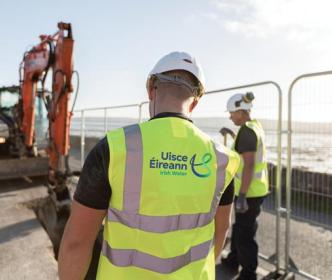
[102, 239, 214, 274]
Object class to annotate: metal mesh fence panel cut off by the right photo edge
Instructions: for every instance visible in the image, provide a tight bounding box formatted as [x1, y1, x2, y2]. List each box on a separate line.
[285, 71, 332, 279]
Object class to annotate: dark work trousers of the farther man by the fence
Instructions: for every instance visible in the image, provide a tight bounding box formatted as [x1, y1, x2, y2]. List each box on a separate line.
[228, 197, 264, 280]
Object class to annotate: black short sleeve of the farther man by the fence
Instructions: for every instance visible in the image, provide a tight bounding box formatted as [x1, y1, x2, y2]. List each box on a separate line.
[235, 125, 257, 154]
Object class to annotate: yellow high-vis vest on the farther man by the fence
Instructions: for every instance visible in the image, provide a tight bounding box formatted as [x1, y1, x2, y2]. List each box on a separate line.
[233, 120, 269, 197]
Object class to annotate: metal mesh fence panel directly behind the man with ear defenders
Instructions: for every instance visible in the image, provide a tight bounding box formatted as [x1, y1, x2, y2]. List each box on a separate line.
[192, 81, 282, 270]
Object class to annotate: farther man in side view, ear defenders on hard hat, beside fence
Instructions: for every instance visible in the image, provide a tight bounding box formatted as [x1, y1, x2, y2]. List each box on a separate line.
[222, 92, 268, 280]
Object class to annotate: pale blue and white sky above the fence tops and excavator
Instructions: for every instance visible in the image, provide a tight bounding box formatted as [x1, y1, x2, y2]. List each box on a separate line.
[0, 0, 332, 121]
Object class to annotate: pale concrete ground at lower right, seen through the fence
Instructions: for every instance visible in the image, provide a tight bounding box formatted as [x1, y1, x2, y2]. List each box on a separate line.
[257, 212, 332, 280]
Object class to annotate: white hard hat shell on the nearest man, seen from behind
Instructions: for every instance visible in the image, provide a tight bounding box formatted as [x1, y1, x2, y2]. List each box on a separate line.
[146, 52, 205, 95]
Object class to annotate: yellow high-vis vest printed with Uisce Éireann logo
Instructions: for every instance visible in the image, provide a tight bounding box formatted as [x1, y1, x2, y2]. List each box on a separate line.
[97, 117, 240, 280]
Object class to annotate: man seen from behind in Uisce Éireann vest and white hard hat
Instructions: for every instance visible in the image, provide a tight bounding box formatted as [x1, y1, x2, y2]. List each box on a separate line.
[59, 52, 240, 280]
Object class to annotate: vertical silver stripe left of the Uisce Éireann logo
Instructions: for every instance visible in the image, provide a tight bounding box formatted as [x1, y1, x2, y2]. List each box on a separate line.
[123, 124, 143, 212]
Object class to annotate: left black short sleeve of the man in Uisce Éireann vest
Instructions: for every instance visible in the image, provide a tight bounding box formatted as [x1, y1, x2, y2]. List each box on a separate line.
[74, 137, 112, 209]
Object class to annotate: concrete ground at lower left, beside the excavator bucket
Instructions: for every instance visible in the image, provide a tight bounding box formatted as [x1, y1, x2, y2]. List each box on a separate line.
[0, 180, 58, 280]
